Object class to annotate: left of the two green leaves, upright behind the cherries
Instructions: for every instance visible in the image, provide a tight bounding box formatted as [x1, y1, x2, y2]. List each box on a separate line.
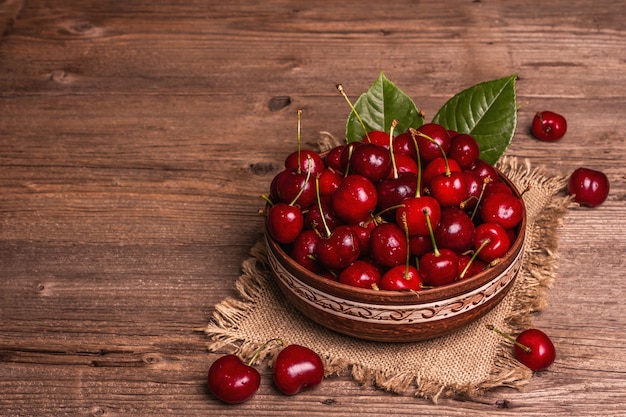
[346, 72, 424, 142]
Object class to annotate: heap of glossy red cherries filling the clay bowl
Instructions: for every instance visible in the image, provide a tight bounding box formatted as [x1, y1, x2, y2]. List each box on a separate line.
[266, 123, 524, 291]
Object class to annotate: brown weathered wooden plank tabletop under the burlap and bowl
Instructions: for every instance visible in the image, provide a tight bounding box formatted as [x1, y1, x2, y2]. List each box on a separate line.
[0, 0, 626, 416]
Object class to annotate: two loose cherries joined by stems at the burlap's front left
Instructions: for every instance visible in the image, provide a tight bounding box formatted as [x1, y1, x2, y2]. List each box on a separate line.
[208, 339, 324, 404]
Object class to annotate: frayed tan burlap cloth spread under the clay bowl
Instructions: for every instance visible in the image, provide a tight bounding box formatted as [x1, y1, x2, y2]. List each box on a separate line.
[203, 152, 572, 402]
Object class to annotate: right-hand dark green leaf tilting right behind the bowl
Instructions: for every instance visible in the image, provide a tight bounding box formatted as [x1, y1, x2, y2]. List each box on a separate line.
[433, 74, 517, 165]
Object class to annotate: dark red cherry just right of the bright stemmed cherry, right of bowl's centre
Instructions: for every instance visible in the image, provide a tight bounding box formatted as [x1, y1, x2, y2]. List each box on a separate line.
[435, 207, 476, 253]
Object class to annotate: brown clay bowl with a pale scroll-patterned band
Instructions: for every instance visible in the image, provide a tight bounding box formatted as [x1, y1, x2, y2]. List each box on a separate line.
[265, 168, 527, 342]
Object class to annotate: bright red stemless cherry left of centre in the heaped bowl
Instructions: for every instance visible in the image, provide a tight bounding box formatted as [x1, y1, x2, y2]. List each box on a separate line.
[332, 174, 378, 223]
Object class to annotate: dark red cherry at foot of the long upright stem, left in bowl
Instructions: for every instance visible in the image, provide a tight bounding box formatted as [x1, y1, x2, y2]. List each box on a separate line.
[315, 225, 361, 271]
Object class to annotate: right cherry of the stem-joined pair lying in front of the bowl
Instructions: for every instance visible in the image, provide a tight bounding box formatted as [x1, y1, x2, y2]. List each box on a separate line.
[273, 345, 324, 395]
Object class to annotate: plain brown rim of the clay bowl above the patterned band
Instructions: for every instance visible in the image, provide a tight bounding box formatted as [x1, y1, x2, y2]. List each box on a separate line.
[265, 167, 528, 305]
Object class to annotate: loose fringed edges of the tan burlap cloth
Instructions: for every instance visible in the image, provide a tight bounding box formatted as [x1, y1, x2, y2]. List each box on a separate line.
[201, 137, 575, 403]
